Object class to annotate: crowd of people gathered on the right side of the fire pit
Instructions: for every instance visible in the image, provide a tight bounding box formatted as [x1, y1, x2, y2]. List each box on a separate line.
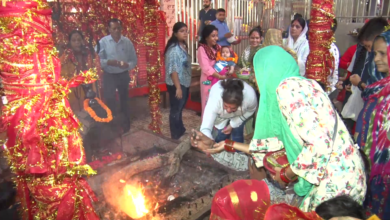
[161, 0, 390, 219]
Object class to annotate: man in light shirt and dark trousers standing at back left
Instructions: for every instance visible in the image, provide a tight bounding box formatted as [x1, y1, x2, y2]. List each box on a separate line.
[99, 18, 137, 133]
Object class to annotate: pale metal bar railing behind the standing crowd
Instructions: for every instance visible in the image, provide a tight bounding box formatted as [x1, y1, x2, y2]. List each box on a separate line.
[175, 0, 390, 64]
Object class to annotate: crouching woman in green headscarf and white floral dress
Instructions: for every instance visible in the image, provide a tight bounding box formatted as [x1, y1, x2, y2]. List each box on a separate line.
[194, 46, 366, 212]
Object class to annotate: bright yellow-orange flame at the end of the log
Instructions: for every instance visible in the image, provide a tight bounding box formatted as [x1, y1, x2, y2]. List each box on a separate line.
[119, 180, 158, 219]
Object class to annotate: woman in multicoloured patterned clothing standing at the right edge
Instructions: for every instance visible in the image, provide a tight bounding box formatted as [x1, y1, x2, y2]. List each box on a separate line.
[358, 31, 390, 220]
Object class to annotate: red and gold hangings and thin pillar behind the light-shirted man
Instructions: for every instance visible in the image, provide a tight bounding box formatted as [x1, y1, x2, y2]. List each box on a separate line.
[49, 0, 167, 133]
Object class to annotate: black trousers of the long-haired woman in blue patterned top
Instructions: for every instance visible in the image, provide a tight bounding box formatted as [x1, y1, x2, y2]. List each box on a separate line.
[167, 85, 190, 140]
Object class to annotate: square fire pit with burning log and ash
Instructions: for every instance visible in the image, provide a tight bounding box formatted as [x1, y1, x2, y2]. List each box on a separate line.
[88, 130, 248, 220]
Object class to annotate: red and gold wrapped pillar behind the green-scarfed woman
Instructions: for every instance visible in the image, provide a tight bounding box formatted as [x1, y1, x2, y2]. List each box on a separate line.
[306, 0, 335, 88]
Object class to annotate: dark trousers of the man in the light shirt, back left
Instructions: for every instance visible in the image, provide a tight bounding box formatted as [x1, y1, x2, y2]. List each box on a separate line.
[103, 71, 130, 130]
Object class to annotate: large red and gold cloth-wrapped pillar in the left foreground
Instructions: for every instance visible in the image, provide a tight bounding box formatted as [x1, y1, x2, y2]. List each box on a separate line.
[0, 0, 99, 220]
